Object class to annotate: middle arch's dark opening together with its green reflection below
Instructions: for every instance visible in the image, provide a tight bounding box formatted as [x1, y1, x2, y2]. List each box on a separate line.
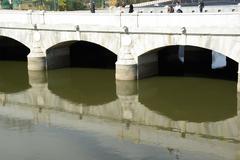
[47, 41, 117, 105]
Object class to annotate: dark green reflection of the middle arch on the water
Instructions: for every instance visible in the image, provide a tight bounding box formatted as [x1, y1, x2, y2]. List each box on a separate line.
[48, 68, 117, 106]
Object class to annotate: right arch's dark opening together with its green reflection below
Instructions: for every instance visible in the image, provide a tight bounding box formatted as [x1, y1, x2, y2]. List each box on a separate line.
[139, 46, 238, 122]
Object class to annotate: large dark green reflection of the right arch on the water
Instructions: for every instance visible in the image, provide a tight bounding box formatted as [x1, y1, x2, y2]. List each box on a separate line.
[138, 76, 237, 122]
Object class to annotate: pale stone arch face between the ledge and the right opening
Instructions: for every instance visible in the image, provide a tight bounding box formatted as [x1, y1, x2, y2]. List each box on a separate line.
[134, 34, 240, 62]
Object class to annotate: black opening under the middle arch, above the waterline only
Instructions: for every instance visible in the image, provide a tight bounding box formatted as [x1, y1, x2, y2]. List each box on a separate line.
[47, 41, 117, 69]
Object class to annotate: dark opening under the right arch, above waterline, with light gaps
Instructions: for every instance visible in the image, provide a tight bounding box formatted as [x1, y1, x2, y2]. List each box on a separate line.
[138, 45, 238, 81]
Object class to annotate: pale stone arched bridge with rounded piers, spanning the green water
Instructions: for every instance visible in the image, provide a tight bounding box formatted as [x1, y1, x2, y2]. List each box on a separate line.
[0, 10, 240, 91]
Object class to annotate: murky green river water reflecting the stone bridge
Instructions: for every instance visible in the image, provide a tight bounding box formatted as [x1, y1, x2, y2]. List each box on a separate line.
[0, 61, 240, 160]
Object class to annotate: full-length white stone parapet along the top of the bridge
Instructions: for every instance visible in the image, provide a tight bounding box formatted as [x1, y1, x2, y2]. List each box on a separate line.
[0, 11, 240, 30]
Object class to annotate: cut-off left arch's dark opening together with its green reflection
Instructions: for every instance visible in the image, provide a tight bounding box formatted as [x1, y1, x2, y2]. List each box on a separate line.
[0, 36, 30, 93]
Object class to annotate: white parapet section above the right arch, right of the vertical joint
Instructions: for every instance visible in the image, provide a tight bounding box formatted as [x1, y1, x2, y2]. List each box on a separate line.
[131, 13, 240, 27]
